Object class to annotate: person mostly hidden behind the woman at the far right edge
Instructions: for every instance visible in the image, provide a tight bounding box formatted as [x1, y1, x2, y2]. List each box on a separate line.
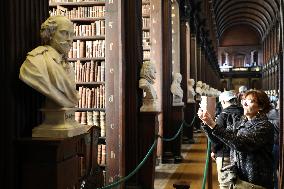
[267, 99, 279, 189]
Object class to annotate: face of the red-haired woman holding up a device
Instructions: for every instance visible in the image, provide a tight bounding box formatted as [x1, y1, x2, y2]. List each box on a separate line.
[242, 95, 260, 119]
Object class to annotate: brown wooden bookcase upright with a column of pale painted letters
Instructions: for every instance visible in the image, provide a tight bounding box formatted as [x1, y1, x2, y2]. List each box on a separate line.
[105, 1, 125, 184]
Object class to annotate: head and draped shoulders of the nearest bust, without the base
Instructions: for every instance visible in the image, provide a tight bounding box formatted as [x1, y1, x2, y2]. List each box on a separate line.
[19, 16, 79, 108]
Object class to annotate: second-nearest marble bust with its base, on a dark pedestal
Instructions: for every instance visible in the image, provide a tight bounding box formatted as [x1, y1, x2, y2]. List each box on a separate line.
[139, 61, 158, 112]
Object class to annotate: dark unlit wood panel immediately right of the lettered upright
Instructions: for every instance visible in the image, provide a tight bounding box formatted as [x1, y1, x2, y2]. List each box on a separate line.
[124, 0, 142, 188]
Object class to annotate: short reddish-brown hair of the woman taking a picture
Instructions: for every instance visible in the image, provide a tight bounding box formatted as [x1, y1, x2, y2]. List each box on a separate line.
[243, 90, 271, 114]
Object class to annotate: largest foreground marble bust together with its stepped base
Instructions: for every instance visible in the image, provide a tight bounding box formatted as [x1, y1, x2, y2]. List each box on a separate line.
[19, 15, 86, 138]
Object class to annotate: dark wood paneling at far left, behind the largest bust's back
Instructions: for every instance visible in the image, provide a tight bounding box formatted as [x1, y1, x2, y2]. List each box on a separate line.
[0, 0, 48, 189]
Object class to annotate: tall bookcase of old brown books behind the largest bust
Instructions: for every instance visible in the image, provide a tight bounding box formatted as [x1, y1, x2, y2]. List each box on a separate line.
[49, 0, 107, 184]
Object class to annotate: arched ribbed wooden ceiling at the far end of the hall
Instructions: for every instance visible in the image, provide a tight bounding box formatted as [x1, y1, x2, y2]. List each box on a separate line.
[212, 0, 279, 39]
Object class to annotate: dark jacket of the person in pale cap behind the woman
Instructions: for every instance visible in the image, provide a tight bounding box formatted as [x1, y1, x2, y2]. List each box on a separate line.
[203, 105, 243, 157]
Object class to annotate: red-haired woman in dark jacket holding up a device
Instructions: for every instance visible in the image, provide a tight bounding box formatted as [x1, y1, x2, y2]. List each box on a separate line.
[198, 90, 274, 189]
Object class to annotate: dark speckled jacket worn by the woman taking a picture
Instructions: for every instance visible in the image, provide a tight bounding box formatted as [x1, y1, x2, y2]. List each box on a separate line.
[212, 115, 274, 189]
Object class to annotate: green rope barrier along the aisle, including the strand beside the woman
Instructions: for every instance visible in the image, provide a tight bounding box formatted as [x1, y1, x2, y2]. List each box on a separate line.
[80, 116, 207, 189]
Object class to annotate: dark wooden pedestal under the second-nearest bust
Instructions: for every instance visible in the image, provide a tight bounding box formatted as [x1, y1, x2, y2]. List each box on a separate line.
[138, 112, 159, 189]
